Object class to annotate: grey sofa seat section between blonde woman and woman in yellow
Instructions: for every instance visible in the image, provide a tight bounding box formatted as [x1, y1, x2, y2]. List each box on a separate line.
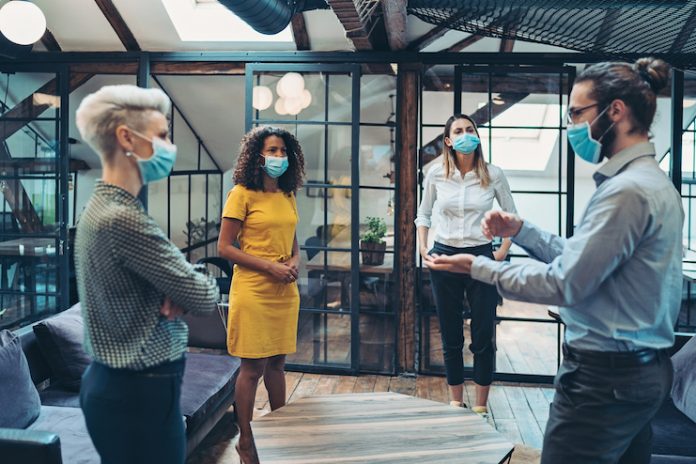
[181, 353, 240, 435]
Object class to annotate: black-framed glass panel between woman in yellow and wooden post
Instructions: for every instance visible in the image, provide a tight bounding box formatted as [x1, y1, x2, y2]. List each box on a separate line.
[246, 65, 397, 373]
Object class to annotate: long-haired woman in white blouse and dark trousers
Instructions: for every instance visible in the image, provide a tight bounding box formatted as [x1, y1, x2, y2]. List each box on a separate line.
[416, 114, 516, 414]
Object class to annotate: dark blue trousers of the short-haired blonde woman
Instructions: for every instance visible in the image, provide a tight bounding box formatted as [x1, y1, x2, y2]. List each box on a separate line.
[80, 358, 186, 464]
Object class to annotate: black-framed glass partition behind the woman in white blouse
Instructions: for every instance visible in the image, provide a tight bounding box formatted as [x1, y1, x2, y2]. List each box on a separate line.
[417, 65, 572, 381]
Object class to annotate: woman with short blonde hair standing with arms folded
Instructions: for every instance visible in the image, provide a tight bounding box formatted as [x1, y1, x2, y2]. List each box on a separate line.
[75, 85, 219, 464]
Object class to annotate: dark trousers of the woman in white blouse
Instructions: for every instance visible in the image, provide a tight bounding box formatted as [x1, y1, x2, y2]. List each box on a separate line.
[430, 242, 498, 386]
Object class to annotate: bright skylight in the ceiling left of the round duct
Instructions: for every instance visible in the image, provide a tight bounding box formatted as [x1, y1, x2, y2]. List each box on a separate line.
[162, 0, 294, 44]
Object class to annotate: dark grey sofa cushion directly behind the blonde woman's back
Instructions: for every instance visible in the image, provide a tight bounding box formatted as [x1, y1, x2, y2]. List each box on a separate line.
[34, 304, 91, 392]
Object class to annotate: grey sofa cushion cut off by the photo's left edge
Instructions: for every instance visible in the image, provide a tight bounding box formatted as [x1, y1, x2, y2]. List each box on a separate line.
[0, 330, 41, 429]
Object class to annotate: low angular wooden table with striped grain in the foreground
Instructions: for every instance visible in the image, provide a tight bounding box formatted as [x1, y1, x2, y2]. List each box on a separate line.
[252, 392, 513, 464]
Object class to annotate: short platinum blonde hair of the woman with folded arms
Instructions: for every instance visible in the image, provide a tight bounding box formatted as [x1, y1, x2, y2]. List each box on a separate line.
[75, 85, 171, 162]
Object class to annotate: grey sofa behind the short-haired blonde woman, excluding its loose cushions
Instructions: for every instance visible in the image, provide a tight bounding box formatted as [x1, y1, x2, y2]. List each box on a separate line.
[0, 304, 240, 464]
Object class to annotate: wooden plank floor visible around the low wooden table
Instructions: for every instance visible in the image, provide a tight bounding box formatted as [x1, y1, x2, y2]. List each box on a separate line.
[187, 372, 553, 464]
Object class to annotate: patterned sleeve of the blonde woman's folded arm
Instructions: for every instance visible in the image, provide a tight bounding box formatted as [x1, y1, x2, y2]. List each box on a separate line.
[110, 212, 220, 313]
